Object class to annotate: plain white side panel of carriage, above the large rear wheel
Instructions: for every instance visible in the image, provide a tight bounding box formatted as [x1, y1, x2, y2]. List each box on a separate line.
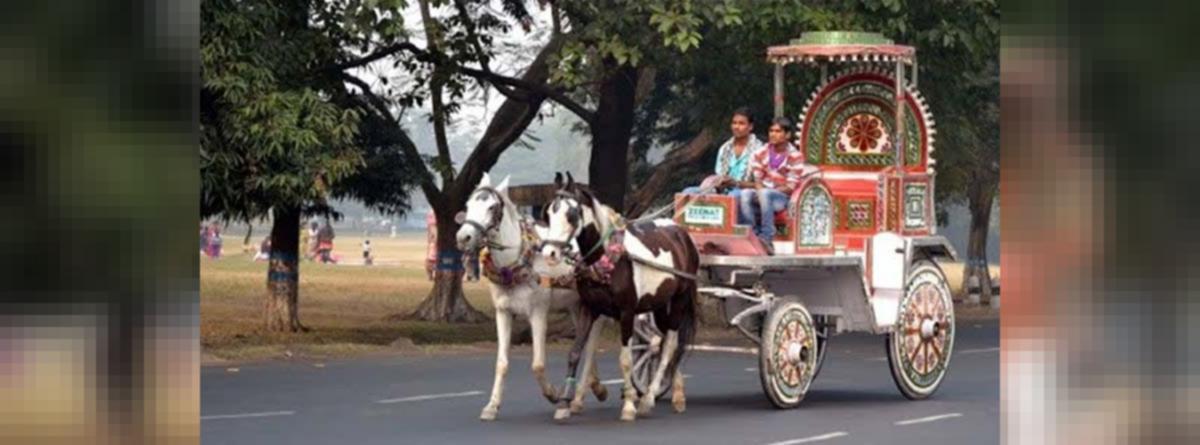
[868, 231, 908, 332]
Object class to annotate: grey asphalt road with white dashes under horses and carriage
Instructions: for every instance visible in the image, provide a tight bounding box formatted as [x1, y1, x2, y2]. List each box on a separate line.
[200, 321, 1000, 445]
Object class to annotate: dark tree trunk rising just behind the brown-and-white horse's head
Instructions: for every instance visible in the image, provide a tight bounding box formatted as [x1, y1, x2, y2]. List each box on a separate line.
[588, 66, 638, 209]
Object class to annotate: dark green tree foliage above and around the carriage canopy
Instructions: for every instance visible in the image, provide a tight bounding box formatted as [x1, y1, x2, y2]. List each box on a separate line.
[588, 0, 1000, 215]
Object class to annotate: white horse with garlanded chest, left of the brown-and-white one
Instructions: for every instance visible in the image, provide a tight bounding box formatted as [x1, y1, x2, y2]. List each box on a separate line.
[456, 173, 608, 420]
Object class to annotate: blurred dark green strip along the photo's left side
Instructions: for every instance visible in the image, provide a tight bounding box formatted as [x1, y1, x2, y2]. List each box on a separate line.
[0, 0, 199, 444]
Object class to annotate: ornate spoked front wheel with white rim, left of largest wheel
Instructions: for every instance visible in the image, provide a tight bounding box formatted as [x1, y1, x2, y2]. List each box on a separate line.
[770, 308, 817, 403]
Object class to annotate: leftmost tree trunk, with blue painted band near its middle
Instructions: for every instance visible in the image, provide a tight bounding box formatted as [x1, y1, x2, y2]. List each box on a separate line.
[264, 208, 306, 332]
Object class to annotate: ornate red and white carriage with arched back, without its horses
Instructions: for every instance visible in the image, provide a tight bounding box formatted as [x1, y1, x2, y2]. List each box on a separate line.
[634, 32, 955, 408]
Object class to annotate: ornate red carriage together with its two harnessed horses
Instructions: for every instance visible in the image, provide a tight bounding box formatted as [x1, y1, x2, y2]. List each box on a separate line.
[456, 32, 955, 420]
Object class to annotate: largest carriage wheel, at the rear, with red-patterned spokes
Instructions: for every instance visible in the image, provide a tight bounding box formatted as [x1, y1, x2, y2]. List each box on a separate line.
[887, 260, 954, 401]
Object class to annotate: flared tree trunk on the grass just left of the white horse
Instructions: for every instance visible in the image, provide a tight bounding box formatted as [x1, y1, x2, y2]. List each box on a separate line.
[408, 205, 487, 323]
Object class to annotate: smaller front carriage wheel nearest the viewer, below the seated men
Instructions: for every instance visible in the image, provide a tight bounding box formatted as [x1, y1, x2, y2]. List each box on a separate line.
[758, 301, 818, 408]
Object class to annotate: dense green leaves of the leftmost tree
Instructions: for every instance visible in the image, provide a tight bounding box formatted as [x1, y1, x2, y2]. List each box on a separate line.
[200, 0, 417, 220]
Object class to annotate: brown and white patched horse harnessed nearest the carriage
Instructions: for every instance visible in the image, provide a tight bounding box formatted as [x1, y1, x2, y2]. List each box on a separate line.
[542, 174, 700, 421]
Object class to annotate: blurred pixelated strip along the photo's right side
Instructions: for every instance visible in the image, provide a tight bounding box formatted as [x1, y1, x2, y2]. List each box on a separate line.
[1001, 0, 1200, 444]
